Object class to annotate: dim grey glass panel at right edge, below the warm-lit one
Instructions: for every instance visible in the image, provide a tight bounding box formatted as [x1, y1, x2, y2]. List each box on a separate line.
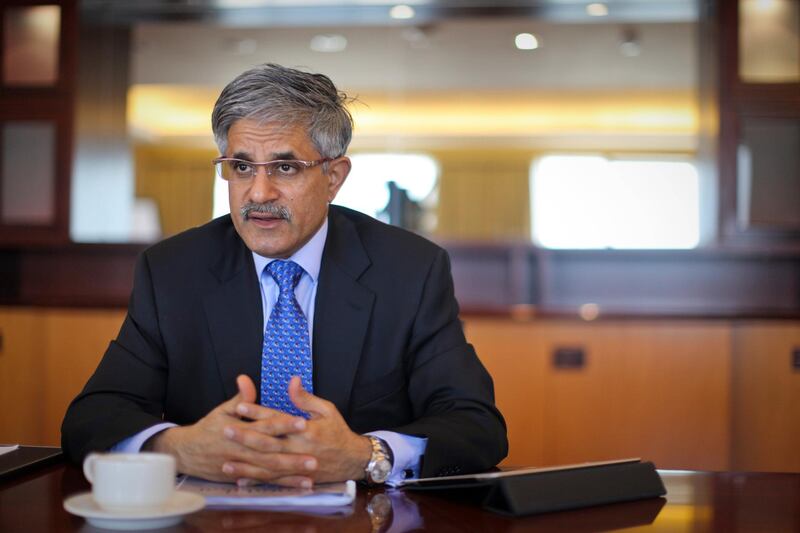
[737, 118, 800, 229]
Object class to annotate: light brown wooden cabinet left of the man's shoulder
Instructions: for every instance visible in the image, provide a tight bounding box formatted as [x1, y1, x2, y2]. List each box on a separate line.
[0, 308, 125, 446]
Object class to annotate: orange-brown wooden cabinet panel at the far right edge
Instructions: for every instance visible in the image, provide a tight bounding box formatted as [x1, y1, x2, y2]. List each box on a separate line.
[732, 322, 800, 472]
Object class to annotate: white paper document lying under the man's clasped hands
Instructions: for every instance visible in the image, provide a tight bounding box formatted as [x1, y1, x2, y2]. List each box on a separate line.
[177, 476, 356, 508]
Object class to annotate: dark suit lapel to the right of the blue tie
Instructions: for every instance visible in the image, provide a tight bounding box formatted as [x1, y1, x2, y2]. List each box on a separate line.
[313, 208, 375, 415]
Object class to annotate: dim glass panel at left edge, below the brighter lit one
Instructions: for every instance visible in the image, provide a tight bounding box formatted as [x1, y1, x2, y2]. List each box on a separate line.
[0, 122, 56, 225]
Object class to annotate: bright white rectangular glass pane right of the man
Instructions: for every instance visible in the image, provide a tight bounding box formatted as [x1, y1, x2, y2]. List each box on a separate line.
[531, 155, 700, 249]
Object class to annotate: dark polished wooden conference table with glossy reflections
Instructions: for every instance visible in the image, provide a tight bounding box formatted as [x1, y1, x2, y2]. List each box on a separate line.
[0, 463, 800, 533]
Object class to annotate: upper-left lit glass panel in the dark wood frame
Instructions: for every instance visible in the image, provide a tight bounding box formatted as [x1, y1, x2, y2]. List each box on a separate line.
[3, 6, 61, 85]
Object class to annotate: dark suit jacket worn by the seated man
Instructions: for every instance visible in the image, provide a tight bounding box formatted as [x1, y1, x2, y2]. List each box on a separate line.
[62, 207, 507, 476]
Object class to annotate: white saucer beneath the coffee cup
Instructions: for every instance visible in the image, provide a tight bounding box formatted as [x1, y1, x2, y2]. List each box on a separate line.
[64, 490, 206, 530]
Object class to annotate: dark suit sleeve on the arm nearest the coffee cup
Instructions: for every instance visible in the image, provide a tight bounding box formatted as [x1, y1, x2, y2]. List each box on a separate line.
[61, 254, 167, 463]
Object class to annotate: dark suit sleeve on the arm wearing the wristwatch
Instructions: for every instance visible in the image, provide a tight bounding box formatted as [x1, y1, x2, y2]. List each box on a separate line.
[391, 250, 508, 477]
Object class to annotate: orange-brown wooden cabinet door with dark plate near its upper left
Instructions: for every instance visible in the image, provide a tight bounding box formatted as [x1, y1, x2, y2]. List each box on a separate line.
[540, 322, 730, 470]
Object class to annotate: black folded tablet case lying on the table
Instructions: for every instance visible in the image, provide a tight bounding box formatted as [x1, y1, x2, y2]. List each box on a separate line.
[405, 462, 667, 516]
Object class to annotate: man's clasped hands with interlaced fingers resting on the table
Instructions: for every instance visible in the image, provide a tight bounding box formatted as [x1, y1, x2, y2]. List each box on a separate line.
[145, 375, 372, 488]
